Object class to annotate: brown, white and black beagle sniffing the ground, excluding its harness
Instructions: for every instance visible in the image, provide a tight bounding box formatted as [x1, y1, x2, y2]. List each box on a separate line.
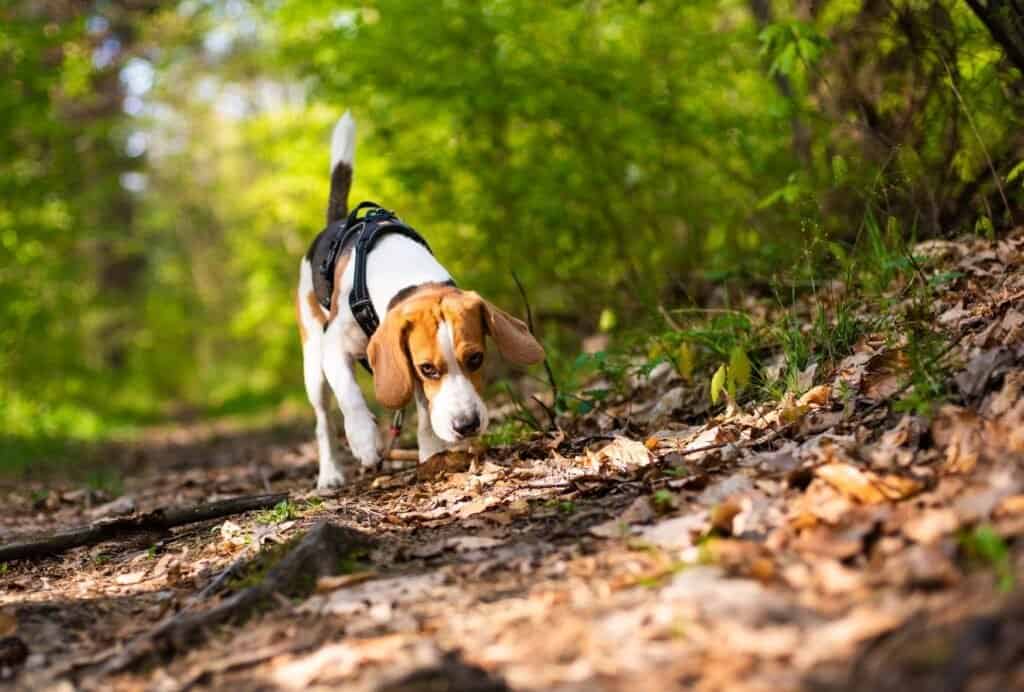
[296, 113, 545, 488]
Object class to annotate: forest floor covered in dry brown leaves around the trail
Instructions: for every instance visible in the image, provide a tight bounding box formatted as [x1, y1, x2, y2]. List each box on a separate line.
[0, 229, 1024, 691]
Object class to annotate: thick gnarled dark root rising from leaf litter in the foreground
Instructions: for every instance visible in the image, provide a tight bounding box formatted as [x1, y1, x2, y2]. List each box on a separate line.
[100, 522, 373, 676]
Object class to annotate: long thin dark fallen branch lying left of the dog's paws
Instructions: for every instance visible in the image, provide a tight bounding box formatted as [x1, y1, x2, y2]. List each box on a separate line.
[0, 492, 288, 562]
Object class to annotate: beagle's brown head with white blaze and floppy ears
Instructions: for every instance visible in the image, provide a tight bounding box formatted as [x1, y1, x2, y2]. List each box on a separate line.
[367, 287, 544, 442]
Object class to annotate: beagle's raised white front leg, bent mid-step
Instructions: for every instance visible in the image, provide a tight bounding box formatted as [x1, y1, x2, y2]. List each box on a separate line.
[324, 320, 380, 469]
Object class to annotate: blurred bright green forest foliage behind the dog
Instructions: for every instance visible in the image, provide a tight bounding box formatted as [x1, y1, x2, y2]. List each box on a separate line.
[0, 0, 1024, 462]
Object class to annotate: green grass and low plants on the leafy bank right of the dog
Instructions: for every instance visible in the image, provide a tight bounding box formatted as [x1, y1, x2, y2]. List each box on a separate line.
[524, 199, 959, 427]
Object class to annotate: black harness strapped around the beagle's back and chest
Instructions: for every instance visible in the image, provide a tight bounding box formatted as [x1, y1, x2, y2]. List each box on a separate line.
[313, 202, 442, 338]
